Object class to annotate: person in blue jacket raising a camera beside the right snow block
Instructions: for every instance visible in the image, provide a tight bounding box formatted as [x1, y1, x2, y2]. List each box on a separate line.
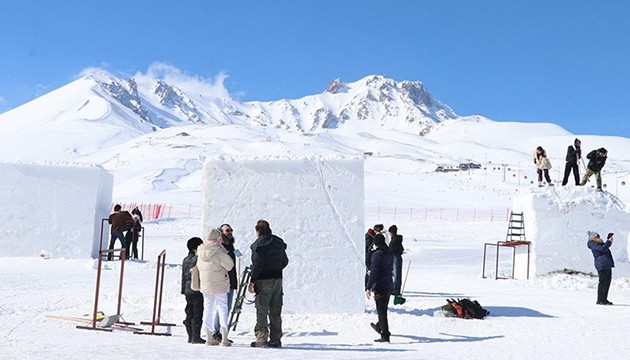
[586, 231, 615, 305]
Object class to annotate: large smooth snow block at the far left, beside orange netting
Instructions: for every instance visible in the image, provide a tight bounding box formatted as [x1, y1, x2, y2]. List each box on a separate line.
[0, 164, 113, 258]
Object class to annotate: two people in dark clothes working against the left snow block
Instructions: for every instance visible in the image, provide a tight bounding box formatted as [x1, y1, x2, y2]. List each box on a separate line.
[107, 204, 143, 261]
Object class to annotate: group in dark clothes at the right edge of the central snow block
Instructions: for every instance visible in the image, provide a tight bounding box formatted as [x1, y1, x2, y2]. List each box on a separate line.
[365, 224, 405, 342]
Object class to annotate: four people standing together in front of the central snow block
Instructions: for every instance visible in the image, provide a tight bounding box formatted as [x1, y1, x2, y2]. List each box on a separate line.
[181, 220, 289, 348]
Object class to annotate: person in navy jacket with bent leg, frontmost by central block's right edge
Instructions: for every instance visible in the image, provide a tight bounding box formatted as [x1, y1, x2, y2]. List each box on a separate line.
[365, 234, 394, 342]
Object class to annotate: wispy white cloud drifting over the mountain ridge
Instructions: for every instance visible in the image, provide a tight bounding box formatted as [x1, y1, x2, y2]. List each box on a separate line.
[133, 62, 230, 98]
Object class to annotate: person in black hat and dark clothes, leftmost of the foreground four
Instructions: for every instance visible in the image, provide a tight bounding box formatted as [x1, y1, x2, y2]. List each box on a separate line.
[182, 237, 206, 344]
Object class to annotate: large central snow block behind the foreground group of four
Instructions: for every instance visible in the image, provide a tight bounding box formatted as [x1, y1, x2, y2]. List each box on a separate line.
[203, 158, 365, 313]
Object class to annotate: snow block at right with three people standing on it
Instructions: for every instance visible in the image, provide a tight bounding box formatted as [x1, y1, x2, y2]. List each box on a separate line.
[513, 187, 630, 275]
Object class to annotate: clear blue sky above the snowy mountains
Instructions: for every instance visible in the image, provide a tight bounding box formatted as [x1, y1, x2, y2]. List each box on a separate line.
[0, 0, 630, 137]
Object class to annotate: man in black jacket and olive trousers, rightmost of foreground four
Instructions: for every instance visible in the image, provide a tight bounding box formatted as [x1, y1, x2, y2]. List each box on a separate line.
[248, 220, 289, 348]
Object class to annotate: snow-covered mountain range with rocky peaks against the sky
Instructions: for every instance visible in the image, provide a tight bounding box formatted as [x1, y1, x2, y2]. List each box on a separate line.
[0, 71, 458, 160]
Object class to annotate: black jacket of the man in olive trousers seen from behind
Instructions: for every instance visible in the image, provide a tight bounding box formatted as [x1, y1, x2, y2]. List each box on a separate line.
[250, 235, 289, 282]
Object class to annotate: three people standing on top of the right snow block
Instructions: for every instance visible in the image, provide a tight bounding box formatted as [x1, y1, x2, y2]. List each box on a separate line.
[533, 138, 608, 190]
